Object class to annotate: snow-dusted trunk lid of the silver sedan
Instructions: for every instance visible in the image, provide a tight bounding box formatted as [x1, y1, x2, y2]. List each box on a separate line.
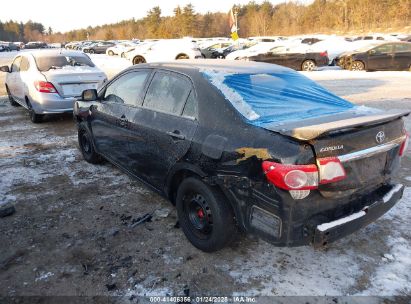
[42, 66, 106, 97]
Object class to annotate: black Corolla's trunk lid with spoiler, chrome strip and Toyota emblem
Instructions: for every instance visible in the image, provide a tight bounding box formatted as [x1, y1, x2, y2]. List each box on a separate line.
[266, 112, 409, 197]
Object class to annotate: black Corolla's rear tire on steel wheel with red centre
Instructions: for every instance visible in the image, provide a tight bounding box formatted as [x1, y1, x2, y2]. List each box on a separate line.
[176, 177, 236, 252]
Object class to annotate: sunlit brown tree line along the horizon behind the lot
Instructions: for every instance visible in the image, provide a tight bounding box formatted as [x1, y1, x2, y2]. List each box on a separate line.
[0, 0, 411, 42]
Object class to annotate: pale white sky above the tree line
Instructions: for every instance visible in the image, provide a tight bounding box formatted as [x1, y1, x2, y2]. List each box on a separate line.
[0, 0, 311, 32]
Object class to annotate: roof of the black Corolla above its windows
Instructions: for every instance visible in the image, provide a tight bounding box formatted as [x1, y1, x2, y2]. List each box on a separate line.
[132, 59, 292, 74]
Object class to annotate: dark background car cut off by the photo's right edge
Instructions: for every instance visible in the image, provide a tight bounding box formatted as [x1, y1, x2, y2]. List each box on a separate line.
[337, 42, 411, 71]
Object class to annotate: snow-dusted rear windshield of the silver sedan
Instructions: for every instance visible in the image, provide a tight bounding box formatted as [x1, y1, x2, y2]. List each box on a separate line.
[35, 54, 94, 72]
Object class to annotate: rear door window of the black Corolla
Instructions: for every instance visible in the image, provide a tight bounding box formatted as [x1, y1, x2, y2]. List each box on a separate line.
[143, 71, 191, 115]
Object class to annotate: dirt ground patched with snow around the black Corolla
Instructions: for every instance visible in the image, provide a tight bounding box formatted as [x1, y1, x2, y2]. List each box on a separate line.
[0, 54, 411, 303]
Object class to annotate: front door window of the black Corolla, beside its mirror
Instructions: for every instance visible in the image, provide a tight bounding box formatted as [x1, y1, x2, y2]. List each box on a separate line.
[103, 71, 150, 106]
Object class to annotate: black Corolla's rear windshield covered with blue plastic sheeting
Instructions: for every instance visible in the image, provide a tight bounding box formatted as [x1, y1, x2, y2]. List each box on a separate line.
[203, 70, 354, 126]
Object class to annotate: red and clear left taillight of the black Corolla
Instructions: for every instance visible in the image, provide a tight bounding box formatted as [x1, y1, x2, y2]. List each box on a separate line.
[262, 157, 346, 190]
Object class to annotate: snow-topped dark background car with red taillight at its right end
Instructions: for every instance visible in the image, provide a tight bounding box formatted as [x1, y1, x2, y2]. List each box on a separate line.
[243, 46, 329, 71]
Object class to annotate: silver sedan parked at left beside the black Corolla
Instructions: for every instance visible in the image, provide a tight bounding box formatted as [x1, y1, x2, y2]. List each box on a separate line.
[0, 50, 107, 123]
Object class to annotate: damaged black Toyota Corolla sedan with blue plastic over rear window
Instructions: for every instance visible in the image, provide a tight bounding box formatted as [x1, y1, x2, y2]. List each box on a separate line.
[74, 60, 408, 251]
